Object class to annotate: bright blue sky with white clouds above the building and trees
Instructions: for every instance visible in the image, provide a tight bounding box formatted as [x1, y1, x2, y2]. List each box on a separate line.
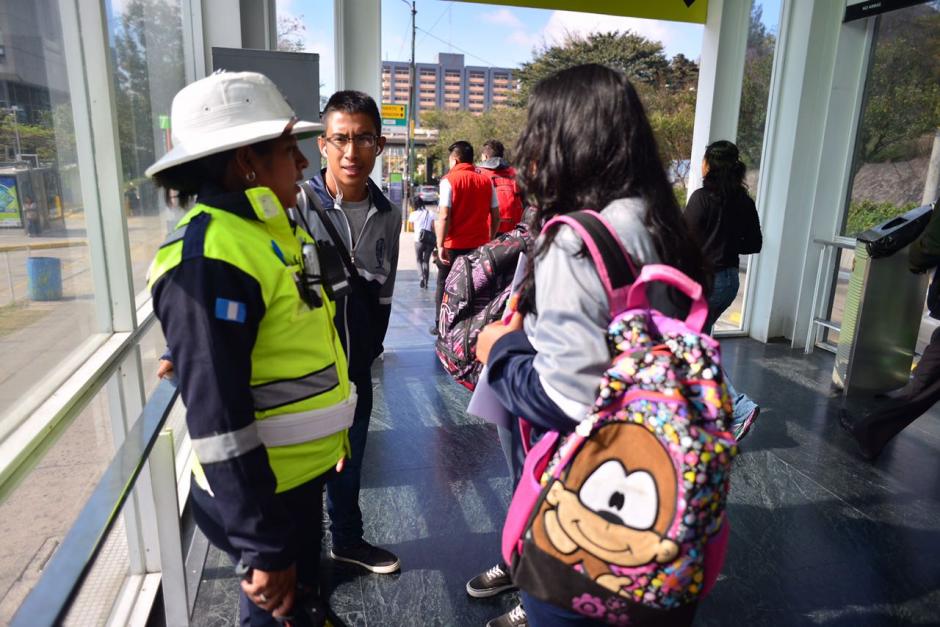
[277, 0, 781, 99]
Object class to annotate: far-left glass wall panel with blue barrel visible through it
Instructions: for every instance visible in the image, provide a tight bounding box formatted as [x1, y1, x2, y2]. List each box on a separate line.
[0, 0, 100, 426]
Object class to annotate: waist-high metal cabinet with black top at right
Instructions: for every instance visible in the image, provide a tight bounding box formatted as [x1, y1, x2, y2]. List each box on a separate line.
[832, 205, 932, 396]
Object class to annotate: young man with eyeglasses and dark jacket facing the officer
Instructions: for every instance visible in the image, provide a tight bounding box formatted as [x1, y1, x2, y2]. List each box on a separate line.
[297, 90, 401, 573]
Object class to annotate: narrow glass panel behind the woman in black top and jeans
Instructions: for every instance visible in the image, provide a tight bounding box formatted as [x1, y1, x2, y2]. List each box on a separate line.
[715, 0, 781, 332]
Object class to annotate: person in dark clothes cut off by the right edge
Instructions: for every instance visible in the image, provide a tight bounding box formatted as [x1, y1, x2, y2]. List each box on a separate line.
[839, 203, 940, 461]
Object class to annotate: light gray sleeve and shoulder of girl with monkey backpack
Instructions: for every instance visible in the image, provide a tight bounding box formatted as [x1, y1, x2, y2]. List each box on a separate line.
[525, 200, 657, 420]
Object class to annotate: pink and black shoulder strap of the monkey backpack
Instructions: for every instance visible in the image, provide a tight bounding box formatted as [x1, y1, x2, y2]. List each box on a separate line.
[542, 209, 638, 317]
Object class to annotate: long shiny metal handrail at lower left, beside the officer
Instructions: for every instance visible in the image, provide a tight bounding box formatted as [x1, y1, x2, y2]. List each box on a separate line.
[10, 379, 179, 627]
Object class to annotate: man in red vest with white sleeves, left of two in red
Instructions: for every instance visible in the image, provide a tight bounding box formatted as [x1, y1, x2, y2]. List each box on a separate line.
[431, 141, 499, 335]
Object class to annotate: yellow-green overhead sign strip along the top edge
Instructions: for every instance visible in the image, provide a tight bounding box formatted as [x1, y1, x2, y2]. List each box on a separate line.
[448, 0, 708, 24]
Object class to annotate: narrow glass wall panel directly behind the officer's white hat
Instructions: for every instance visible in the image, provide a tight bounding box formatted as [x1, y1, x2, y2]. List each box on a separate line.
[107, 0, 186, 293]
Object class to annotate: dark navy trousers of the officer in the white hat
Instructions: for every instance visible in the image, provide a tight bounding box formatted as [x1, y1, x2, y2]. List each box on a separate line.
[190, 471, 333, 627]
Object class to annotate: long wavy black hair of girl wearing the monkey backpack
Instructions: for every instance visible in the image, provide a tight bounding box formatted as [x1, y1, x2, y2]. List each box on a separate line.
[515, 63, 708, 313]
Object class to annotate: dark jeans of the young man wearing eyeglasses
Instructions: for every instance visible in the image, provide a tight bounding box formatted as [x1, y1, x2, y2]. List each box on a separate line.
[326, 373, 372, 547]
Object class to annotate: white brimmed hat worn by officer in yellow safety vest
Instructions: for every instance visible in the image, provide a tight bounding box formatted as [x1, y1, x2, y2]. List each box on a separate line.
[146, 71, 323, 176]
